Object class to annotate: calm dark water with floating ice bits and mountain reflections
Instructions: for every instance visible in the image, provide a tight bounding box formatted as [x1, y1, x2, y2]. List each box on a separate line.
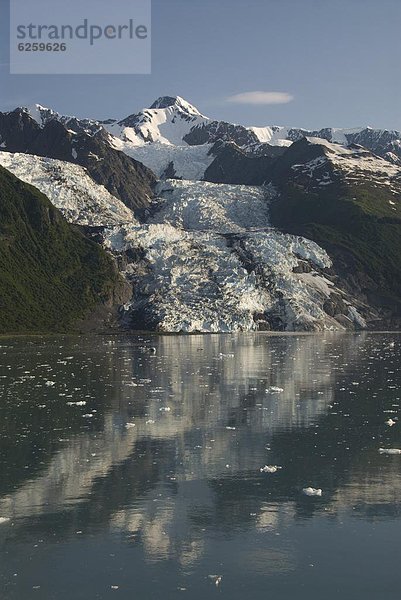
[0, 333, 401, 600]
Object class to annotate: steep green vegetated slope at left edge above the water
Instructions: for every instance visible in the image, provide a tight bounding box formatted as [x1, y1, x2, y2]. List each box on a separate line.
[0, 167, 118, 333]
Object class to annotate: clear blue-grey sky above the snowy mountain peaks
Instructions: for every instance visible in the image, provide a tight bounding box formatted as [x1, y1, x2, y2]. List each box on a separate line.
[0, 0, 401, 129]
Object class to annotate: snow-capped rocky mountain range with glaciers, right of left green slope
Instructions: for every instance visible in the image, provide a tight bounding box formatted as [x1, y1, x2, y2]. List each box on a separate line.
[0, 96, 401, 331]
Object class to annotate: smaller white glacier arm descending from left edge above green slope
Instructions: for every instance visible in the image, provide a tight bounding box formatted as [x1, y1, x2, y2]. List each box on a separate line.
[0, 152, 136, 227]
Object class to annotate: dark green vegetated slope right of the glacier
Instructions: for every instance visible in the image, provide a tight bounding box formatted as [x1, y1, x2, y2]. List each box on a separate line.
[271, 180, 401, 315]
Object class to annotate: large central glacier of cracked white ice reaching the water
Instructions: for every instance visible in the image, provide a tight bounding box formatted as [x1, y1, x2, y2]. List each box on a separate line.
[104, 180, 363, 333]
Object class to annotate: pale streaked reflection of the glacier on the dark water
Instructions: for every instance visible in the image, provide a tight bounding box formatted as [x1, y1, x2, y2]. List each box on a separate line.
[0, 335, 340, 517]
